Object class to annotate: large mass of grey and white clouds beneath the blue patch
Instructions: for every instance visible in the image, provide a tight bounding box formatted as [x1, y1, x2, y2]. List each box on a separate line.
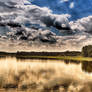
[0, 0, 92, 51]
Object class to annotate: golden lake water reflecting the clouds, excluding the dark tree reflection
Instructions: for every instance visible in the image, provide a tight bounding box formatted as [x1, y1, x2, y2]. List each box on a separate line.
[0, 58, 92, 92]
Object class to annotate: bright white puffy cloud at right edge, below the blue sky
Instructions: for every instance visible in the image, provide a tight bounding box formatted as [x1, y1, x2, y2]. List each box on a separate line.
[70, 16, 92, 33]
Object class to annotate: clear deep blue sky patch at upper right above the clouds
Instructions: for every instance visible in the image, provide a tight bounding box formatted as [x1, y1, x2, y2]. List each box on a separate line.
[29, 0, 92, 20]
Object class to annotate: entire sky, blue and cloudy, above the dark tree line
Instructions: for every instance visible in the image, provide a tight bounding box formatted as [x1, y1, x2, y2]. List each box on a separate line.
[0, 0, 92, 51]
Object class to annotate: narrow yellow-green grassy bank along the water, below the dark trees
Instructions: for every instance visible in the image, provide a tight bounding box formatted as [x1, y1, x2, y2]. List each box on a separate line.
[17, 56, 92, 62]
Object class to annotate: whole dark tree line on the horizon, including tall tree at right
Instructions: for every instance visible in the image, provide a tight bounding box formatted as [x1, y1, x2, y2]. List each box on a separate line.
[0, 45, 92, 57]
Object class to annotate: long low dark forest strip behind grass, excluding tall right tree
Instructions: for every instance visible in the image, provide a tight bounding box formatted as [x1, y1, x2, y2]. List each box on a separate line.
[17, 51, 81, 56]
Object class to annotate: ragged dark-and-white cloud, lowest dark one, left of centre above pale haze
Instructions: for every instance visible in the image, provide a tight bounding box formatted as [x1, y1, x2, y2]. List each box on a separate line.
[7, 28, 56, 43]
